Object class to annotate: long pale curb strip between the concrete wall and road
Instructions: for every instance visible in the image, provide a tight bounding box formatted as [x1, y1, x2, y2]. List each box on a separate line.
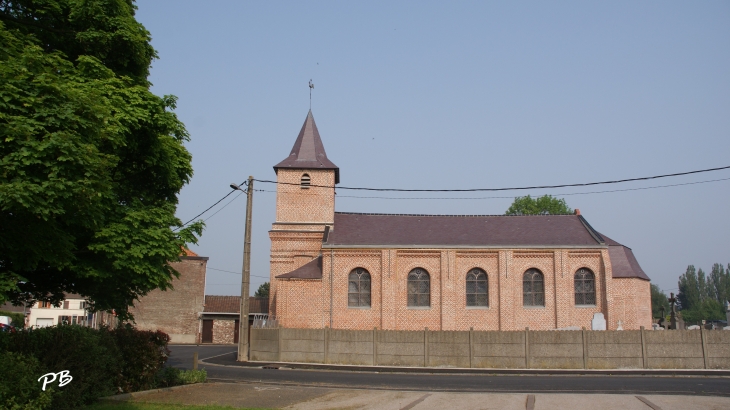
[199, 359, 730, 377]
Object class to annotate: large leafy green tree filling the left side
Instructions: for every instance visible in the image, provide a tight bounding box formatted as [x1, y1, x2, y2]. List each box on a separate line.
[0, 0, 203, 318]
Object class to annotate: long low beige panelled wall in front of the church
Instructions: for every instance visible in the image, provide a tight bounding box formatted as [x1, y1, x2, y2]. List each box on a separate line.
[251, 328, 730, 369]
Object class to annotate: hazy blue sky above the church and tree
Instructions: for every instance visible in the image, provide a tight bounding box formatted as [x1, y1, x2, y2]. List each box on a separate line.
[137, 0, 730, 295]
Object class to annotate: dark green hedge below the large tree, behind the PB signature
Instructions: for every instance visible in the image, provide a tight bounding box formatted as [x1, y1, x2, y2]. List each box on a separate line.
[0, 325, 173, 409]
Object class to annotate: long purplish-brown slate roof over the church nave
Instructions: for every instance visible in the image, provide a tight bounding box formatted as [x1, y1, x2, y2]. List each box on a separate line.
[324, 212, 605, 248]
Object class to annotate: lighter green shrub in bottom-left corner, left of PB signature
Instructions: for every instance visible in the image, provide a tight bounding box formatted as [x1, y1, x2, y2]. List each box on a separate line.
[0, 351, 54, 410]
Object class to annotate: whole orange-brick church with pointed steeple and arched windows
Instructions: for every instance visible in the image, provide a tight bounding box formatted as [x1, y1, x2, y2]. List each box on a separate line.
[269, 111, 651, 330]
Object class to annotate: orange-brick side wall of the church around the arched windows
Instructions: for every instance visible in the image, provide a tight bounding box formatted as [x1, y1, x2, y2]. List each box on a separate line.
[272, 248, 651, 331]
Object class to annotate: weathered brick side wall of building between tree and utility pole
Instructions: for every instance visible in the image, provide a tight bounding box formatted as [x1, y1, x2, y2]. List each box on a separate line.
[130, 256, 208, 343]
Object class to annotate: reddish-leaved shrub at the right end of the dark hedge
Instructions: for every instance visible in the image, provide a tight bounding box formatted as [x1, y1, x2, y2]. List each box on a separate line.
[110, 325, 170, 392]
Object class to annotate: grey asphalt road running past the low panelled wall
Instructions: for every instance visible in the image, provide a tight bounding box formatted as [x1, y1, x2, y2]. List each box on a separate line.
[168, 346, 730, 397]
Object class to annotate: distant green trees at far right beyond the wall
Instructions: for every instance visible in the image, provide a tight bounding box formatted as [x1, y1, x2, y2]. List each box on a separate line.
[677, 263, 730, 323]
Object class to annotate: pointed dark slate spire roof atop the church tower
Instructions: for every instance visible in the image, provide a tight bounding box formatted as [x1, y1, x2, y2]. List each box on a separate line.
[274, 110, 340, 184]
